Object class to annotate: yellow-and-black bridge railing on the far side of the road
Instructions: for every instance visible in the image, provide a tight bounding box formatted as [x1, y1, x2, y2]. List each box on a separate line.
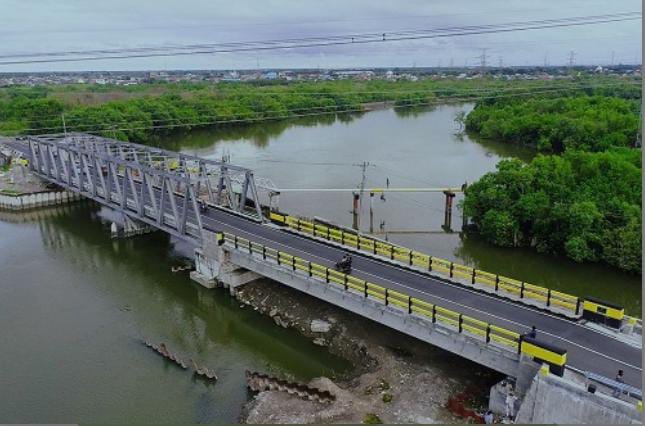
[270, 212, 582, 316]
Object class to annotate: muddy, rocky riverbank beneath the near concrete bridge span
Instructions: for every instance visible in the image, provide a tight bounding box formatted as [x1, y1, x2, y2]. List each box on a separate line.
[235, 280, 500, 423]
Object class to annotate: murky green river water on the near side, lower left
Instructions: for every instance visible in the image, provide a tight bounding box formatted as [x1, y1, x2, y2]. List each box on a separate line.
[0, 204, 348, 423]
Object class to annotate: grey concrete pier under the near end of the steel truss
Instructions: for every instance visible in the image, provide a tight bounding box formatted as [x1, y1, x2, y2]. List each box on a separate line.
[190, 230, 261, 294]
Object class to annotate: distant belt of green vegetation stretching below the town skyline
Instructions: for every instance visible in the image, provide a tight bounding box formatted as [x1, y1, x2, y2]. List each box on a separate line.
[0, 77, 638, 143]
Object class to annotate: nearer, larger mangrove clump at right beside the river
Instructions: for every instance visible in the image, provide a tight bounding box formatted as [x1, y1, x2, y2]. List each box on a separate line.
[463, 148, 642, 273]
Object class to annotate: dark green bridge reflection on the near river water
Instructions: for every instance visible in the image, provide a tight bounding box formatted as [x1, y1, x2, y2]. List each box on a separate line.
[39, 206, 343, 377]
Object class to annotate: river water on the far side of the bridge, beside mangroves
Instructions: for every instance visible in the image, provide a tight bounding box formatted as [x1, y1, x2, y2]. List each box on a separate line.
[170, 104, 641, 316]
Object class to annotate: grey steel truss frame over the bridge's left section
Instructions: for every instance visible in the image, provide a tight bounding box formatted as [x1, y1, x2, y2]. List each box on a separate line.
[27, 134, 264, 243]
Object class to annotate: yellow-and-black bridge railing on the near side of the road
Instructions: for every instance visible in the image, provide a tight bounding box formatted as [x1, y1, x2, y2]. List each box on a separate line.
[218, 232, 566, 371]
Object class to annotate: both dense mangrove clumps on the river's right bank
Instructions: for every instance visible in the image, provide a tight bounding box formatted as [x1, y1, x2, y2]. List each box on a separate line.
[463, 94, 642, 273]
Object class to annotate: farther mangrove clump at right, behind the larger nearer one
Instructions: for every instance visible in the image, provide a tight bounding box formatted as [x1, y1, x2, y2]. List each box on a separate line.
[466, 96, 640, 153]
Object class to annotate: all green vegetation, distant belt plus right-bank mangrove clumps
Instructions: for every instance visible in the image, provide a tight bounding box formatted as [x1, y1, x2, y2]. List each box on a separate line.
[0, 76, 642, 272]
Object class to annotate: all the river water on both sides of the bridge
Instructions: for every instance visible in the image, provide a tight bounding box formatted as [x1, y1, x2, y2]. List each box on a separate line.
[0, 105, 641, 423]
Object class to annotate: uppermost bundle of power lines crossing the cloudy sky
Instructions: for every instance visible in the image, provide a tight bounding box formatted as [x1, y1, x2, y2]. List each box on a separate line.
[0, 12, 642, 65]
